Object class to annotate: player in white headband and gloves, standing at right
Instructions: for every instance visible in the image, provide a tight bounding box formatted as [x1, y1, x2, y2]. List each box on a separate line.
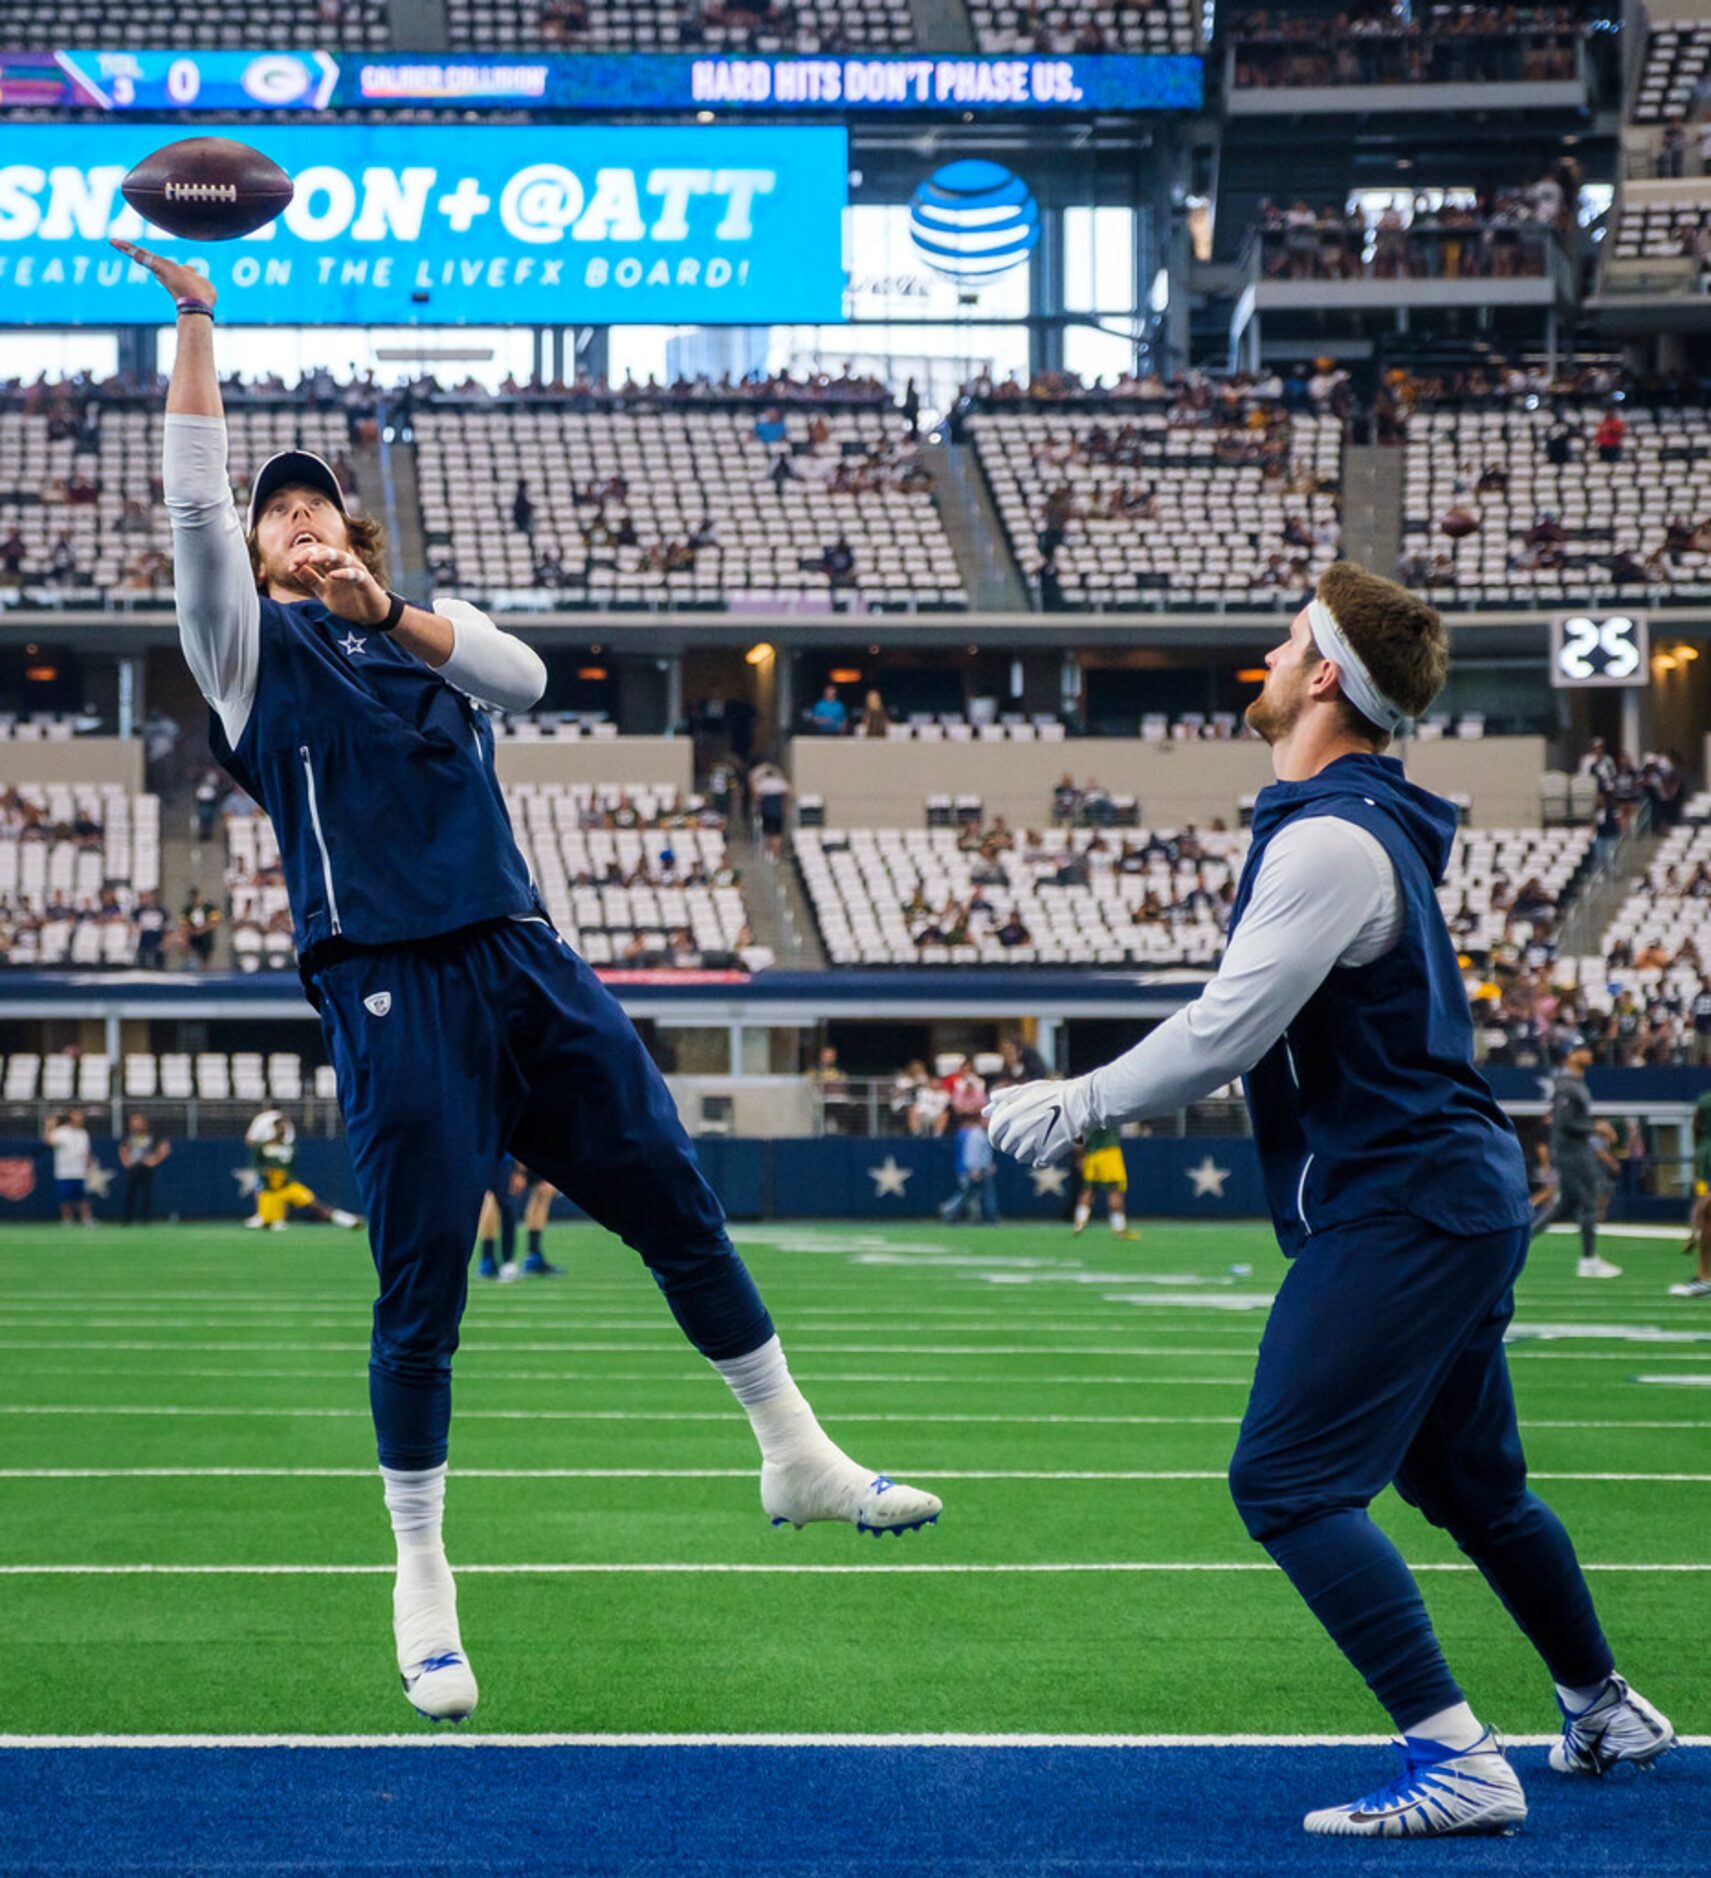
[990, 562, 1673, 1837]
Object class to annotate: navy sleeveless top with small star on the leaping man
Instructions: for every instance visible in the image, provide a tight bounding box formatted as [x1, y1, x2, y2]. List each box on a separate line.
[208, 595, 543, 975]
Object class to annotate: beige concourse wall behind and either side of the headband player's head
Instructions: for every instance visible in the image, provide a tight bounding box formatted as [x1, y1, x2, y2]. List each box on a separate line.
[791, 736, 1546, 828]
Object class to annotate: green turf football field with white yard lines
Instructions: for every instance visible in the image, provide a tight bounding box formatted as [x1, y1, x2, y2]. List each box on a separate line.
[0, 1223, 1711, 1735]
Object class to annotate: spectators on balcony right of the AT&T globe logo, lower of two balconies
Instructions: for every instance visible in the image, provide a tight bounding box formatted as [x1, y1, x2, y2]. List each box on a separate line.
[1255, 162, 1580, 280]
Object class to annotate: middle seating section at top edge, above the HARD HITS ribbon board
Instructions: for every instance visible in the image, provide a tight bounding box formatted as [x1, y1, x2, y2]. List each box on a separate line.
[445, 0, 915, 53]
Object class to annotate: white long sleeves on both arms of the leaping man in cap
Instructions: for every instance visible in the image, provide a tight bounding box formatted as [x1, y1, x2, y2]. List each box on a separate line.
[162, 411, 547, 744]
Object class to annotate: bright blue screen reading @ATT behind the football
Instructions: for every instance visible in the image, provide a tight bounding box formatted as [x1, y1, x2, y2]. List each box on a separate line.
[0, 124, 849, 327]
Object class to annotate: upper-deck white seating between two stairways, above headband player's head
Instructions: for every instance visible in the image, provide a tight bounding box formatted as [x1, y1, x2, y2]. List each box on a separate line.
[969, 408, 1343, 608]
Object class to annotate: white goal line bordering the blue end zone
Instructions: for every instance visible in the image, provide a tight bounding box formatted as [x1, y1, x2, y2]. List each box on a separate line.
[0, 1732, 1711, 1752]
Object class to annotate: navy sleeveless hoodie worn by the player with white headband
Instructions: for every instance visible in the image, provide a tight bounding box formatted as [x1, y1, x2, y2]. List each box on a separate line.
[1230, 755, 1529, 1256]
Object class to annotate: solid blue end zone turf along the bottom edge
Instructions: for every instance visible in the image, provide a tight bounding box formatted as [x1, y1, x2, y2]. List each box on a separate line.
[0, 1747, 1711, 1878]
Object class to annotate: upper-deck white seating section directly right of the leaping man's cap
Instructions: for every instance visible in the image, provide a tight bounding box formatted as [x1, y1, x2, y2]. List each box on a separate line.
[415, 406, 967, 608]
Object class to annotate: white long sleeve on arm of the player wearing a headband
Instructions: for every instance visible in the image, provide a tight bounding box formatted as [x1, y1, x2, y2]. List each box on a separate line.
[1087, 815, 1405, 1127]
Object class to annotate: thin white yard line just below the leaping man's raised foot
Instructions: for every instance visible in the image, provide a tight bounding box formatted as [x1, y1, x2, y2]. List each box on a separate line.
[0, 1559, 1711, 1578]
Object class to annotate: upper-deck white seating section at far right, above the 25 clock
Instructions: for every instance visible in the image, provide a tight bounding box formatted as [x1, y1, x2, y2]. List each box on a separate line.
[1403, 400, 1711, 607]
